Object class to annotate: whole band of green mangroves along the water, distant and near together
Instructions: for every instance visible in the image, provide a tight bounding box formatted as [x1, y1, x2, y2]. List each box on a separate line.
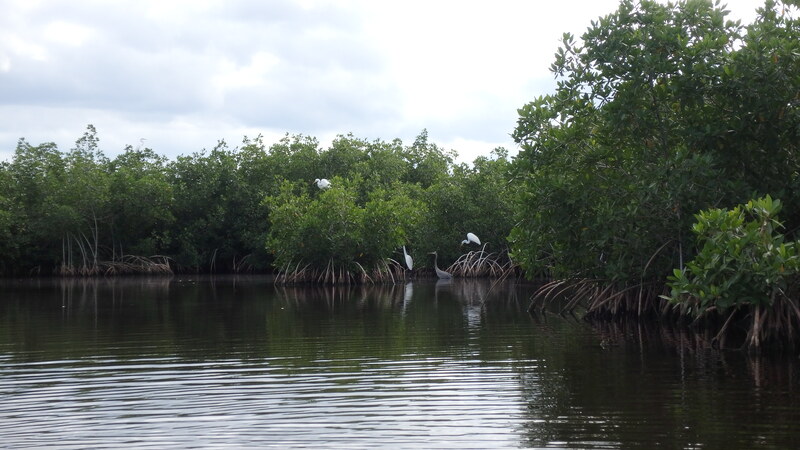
[0, 0, 800, 349]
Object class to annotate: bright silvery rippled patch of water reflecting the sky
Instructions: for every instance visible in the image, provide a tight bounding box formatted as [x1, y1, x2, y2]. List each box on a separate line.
[0, 358, 535, 448]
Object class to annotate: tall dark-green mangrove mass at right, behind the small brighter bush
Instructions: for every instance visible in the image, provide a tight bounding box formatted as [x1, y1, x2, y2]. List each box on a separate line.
[511, 0, 800, 345]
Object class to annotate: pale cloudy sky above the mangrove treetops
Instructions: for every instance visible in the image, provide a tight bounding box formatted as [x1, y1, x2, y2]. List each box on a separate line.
[0, 0, 763, 162]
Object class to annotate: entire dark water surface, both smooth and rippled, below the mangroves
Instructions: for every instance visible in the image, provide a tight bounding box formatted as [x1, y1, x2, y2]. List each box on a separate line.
[0, 277, 800, 449]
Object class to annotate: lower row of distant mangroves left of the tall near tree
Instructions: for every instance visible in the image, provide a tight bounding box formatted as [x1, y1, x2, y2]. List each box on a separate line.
[0, 125, 511, 274]
